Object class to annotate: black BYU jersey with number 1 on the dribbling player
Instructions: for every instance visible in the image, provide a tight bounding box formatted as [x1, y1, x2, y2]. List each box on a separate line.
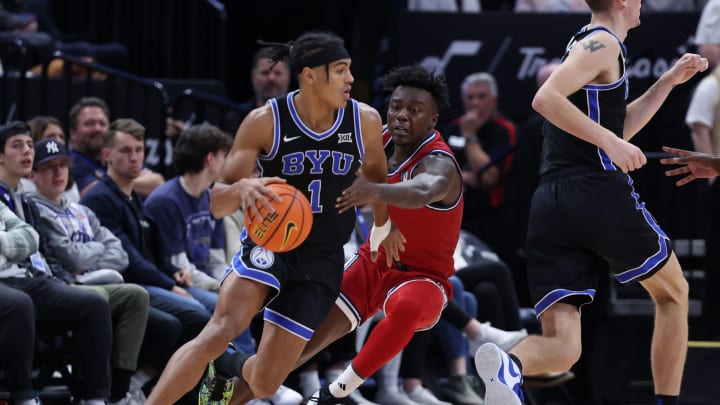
[258, 91, 364, 247]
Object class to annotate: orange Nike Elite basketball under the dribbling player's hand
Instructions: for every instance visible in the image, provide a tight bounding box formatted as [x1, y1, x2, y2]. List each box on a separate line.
[244, 183, 313, 252]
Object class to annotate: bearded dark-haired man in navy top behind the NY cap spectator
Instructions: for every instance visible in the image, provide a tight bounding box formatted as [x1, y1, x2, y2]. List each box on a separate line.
[68, 97, 165, 197]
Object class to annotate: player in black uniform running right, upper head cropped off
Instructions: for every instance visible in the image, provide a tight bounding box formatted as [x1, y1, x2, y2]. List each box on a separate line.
[475, 0, 708, 405]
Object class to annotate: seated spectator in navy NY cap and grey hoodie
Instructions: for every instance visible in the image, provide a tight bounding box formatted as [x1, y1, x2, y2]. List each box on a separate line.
[26, 139, 149, 405]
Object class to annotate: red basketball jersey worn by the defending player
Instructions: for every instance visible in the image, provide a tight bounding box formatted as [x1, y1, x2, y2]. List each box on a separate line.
[366, 130, 463, 278]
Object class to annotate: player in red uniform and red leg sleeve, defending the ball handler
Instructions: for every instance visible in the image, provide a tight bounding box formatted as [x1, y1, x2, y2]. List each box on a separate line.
[225, 65, 480, 405]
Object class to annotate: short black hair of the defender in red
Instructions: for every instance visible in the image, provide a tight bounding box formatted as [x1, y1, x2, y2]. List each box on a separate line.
[381, 64, 450, 111]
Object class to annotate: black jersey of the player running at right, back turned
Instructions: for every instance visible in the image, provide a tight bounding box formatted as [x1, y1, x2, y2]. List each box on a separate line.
[540, 26, 628, 176]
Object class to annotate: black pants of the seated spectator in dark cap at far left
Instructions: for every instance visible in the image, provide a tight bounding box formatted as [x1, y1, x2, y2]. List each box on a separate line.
[0, 277, 112, 399]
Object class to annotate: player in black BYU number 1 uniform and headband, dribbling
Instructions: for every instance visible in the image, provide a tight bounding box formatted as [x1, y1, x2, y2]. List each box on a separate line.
[142, 32, 400, 404]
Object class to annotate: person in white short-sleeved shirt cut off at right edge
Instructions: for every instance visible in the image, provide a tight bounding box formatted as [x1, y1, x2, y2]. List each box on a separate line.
[685, 61, 720, 338]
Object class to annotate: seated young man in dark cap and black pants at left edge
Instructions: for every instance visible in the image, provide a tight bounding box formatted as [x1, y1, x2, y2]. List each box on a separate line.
[0, 121, 112, 405]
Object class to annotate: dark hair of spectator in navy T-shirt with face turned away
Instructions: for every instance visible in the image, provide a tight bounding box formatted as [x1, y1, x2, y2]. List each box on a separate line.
[173, 123, 233, 175]
